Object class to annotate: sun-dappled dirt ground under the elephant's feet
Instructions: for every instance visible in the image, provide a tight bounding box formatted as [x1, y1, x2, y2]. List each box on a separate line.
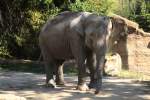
[0, 71, 150, 100]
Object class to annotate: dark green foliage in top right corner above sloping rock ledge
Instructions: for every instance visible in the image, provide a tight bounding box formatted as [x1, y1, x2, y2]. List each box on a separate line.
[129, 0, 150, 32]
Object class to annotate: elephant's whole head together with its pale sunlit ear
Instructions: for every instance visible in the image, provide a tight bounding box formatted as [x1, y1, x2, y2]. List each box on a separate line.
[70, 12, 112, 49]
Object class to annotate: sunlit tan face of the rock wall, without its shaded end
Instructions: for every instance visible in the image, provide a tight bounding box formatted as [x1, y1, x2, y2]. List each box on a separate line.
[127, 34, 150, 73]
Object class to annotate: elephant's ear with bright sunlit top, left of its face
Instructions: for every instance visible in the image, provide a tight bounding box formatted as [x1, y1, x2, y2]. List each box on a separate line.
[70, 16, 84, 37]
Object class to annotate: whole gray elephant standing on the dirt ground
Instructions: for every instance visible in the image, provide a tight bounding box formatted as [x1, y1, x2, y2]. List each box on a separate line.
[39, 12, 127, 93]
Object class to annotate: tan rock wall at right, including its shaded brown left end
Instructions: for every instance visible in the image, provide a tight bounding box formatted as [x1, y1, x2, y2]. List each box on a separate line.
[114, 33, 150, 74]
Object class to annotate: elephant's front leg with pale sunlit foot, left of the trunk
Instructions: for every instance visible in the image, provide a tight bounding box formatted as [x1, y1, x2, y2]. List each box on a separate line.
[70, 34, 89, 91]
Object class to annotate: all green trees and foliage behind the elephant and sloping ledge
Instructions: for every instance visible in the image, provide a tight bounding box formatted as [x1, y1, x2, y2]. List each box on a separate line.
[0, 0, 150, 60]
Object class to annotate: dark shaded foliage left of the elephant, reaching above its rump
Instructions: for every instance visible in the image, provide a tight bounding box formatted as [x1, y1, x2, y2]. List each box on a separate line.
[0, 0, 59, 59]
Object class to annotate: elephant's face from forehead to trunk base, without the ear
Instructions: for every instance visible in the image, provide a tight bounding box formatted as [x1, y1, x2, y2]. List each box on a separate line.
[85, 16, 112, 51]
